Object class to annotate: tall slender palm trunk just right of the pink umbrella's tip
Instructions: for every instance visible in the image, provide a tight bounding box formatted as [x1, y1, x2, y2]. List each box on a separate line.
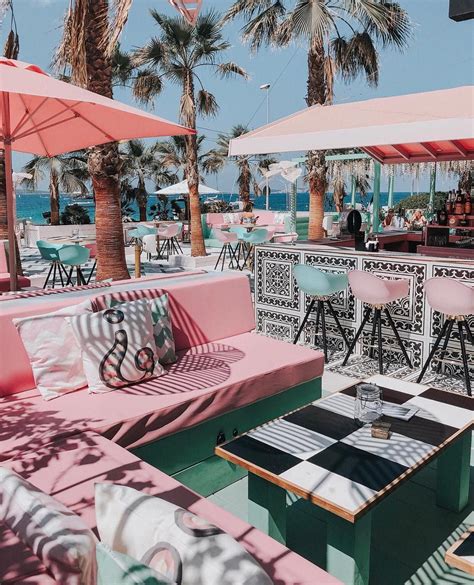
[181, 72, 206, 256]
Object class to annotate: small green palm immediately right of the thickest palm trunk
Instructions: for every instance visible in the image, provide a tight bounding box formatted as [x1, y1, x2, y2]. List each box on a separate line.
[120, 140, 176, 221]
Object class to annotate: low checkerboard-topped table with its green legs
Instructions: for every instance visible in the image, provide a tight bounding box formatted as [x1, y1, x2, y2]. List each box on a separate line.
[215, 376, 474, 585]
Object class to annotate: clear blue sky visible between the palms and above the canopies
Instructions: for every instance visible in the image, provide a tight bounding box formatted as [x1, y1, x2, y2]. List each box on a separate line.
[1, 0, 474, 191]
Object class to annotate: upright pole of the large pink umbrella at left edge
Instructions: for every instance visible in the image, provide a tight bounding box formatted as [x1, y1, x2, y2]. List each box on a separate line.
[2, 92, 18, 292]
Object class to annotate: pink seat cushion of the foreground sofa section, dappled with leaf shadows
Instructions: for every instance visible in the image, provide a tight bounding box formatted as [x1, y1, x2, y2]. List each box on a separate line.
[1, 433, 339, 585]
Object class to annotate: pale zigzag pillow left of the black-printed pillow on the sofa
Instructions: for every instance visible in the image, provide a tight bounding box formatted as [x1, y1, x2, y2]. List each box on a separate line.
[13, 300, 92, 400]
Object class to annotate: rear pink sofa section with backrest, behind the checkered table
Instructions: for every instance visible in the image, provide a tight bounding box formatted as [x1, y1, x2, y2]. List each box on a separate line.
[0, 274, 324, 460]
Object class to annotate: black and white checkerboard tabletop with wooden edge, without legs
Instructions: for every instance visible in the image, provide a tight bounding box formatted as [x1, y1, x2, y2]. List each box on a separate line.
[216, 376, 474, 522]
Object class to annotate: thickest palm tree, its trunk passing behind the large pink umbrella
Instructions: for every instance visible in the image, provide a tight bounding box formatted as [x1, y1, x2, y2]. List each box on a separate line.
[56, 0, 132, 280]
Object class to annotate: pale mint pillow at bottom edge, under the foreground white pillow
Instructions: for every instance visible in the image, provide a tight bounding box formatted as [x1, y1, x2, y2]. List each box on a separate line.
[96, 542, 175, 585]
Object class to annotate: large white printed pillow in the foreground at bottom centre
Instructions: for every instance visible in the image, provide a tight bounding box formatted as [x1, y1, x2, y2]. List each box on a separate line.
[95, 483, 272, 585]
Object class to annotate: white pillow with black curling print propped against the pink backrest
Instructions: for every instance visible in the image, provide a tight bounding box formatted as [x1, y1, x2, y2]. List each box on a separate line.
[68, 299, 165, 394]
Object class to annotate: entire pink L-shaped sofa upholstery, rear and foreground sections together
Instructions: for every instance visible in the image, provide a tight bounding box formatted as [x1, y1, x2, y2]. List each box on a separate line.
[0, 273, 332, 585]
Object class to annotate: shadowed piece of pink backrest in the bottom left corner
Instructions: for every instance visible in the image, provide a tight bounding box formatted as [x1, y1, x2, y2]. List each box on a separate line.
[0, 522, 54, 585]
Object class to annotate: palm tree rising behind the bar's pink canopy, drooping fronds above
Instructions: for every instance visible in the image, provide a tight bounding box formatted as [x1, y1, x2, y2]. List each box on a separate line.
[225, 0, 412, 239]
